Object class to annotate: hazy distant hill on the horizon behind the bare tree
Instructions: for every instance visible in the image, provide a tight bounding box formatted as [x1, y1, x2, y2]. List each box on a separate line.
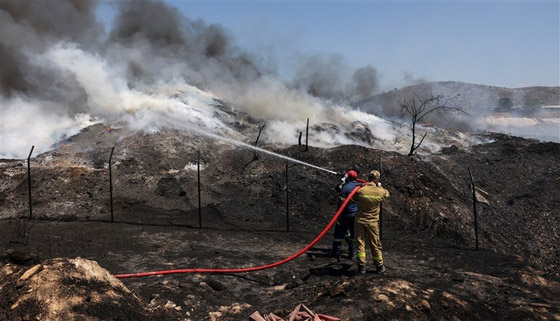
[354, 81, 560, 116]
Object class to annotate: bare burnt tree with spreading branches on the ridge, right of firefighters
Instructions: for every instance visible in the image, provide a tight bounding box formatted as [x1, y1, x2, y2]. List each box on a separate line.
[399, 94, 468, 156]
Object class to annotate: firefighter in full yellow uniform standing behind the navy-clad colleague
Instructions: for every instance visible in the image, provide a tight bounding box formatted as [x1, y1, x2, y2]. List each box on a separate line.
[352, 170, 389, 274]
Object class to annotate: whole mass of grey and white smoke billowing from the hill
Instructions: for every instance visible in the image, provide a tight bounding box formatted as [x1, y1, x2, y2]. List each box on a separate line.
[0, 0, 398, 157]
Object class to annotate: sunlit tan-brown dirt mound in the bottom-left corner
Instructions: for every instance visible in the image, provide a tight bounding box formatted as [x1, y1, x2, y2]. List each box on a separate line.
[0, 257, 175, 320]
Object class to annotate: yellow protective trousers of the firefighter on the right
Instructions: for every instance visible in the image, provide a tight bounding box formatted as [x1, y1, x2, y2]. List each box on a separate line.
[354, 220, 383, 266]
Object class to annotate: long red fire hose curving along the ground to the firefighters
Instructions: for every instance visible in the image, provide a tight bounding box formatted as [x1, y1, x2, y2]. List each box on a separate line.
[115, 186, 361, 279]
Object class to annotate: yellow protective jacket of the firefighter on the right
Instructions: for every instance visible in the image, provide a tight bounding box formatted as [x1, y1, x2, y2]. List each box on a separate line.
[352, 182, 389, 223]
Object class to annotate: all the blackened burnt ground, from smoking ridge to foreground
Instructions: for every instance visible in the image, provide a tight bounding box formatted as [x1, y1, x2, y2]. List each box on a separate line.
[0, 126, 560, 320]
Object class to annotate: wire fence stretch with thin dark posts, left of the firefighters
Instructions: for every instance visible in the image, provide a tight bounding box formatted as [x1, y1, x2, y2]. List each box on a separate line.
[15, 146, 335, 232]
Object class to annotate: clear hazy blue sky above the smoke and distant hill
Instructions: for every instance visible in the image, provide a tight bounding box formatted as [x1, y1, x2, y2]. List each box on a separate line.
[97, 0, 560, 89]
